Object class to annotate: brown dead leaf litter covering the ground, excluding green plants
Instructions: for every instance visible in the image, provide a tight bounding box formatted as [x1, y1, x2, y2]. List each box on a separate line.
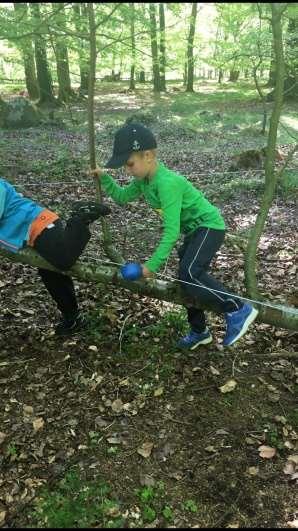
[0, 89, 298, 527]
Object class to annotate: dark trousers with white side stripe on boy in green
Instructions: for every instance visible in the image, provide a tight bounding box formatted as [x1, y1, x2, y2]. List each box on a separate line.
[178, 227, 243, 332]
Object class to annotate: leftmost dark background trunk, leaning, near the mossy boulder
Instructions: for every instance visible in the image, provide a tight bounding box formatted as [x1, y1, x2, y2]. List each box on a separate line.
[13, 2, 39, 100]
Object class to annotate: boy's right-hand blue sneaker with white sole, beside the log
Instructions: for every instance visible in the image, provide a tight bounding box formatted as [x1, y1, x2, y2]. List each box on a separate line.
[222, 304, 259, 347]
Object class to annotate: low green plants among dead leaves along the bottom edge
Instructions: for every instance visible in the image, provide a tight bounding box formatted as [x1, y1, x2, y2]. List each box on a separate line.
[26, 466, 203, 529]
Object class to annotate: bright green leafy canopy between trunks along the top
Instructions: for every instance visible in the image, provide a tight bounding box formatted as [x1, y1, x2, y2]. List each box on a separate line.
[0, 2, 297, 97]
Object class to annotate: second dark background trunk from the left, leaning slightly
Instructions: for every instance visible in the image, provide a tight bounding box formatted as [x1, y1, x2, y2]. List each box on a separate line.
[30, 3, 57, 105]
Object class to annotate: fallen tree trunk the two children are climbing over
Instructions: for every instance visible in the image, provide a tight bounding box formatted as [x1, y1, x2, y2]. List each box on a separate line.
[0, 248, 298, 330]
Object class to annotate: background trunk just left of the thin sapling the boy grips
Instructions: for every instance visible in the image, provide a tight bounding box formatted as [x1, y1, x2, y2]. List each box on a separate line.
[72, 3, 89, 96]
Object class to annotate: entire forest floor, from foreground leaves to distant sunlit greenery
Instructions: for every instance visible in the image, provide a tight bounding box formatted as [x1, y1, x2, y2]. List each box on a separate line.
[0, 83, 298, 528]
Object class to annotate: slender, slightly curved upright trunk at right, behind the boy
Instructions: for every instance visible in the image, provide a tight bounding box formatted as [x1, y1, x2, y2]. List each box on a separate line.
[245, 3, 285, 298]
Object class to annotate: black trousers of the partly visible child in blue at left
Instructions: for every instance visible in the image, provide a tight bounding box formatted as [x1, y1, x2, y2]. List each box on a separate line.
[34, 218, 91, 317]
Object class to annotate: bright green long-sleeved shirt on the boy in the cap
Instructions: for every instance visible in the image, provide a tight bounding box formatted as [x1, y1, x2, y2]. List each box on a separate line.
[101, 163, 225, 273]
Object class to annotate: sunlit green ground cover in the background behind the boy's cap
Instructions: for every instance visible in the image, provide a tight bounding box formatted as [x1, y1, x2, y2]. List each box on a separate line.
[0, 81, 298, 180]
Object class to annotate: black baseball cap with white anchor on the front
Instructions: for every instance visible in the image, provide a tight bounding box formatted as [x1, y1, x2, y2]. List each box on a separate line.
[105, 122, 157, 168]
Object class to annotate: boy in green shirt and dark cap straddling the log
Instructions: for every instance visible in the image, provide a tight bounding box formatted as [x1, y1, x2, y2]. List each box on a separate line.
[90, 123, 258, 350]
